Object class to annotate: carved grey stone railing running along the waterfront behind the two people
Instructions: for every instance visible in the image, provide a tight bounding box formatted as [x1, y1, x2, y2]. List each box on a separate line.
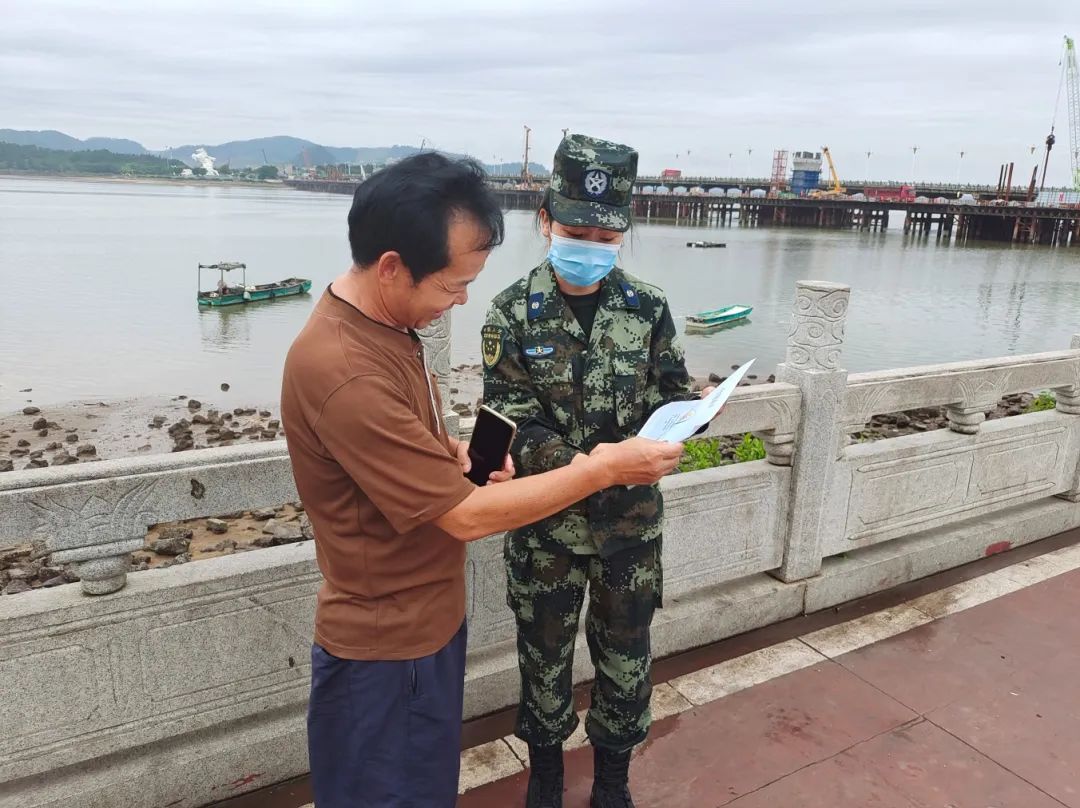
[0, 283, 1080, 808]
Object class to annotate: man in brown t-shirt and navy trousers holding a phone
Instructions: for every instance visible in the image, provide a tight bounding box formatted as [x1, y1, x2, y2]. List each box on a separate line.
[282, 153, 681, 808]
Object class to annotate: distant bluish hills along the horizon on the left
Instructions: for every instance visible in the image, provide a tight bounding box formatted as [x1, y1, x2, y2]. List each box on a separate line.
[0, 129, 548, 176]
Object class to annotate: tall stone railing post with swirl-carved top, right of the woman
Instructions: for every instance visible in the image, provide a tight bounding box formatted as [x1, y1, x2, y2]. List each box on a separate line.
[777, 281, 851, 581]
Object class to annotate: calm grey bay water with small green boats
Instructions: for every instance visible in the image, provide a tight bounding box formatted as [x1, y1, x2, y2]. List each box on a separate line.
[0, 177, 1080, 409]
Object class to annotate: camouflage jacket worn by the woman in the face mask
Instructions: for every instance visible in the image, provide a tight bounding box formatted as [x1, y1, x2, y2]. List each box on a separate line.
[481, 261, 694, 556]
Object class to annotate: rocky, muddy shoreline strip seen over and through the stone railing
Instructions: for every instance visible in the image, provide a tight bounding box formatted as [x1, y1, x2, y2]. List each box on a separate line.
[0, 378, 1035, 595]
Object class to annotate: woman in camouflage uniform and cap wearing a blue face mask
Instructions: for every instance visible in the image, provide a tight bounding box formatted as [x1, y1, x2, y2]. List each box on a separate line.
[482, 135, 708, 808]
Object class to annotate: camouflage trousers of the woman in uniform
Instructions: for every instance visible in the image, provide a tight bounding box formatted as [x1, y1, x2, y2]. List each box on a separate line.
[504, 536, 663, 752]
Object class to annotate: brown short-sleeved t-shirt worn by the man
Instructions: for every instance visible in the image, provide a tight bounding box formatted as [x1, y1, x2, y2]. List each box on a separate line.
[281, 289, 475, 660]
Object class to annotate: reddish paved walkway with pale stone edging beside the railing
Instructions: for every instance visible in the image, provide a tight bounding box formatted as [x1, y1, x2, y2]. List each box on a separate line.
[458, 547, 1080, 808]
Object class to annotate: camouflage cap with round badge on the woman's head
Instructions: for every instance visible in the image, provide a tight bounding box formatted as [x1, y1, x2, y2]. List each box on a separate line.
[551, 135, 637, 232]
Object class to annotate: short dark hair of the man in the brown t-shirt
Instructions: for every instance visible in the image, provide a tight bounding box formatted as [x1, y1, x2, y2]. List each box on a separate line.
[349, 151, 504, 284]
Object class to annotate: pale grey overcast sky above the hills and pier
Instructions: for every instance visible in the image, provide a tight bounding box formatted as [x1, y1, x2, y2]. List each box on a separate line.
[0, 0, 1080, 184]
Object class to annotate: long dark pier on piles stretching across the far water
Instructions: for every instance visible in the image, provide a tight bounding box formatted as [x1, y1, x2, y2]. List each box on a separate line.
[287, 179, 1080, 246]
